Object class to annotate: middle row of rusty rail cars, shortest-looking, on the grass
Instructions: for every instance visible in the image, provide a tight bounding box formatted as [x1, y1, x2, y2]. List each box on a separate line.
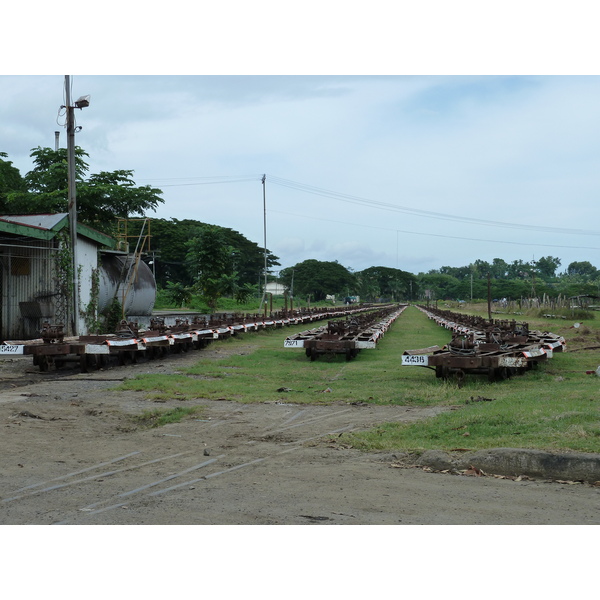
[283, 304, 407, 361]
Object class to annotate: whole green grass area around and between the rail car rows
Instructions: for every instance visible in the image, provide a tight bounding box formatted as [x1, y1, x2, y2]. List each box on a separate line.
[116, 307, 600, 452]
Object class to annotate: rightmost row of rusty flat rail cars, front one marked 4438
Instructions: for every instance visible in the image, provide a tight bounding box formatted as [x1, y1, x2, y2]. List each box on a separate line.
[402, 306, 566, 381]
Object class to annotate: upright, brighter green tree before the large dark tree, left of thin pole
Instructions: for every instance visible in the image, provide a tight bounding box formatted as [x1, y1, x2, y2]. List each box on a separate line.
[186, 225, 237, 312]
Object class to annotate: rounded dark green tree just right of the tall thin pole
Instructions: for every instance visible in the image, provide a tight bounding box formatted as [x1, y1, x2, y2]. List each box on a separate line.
[279, 258, 356, 302]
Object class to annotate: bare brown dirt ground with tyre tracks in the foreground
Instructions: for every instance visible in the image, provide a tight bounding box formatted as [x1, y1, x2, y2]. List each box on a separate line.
[0, 347, 600, 525]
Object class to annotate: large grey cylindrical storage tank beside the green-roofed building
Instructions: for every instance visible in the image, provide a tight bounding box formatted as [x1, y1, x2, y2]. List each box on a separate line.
[98, 252, 156, 317]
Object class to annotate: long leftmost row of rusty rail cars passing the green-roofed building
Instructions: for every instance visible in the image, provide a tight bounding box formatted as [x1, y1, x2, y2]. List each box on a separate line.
[0, 306, 390, 372]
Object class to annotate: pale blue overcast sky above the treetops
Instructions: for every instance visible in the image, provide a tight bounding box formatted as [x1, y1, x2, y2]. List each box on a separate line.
[0, 6, 600, 273]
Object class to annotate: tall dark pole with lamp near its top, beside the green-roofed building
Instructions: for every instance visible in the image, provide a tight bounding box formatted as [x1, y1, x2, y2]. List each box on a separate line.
[61, 75, 90, 335]
